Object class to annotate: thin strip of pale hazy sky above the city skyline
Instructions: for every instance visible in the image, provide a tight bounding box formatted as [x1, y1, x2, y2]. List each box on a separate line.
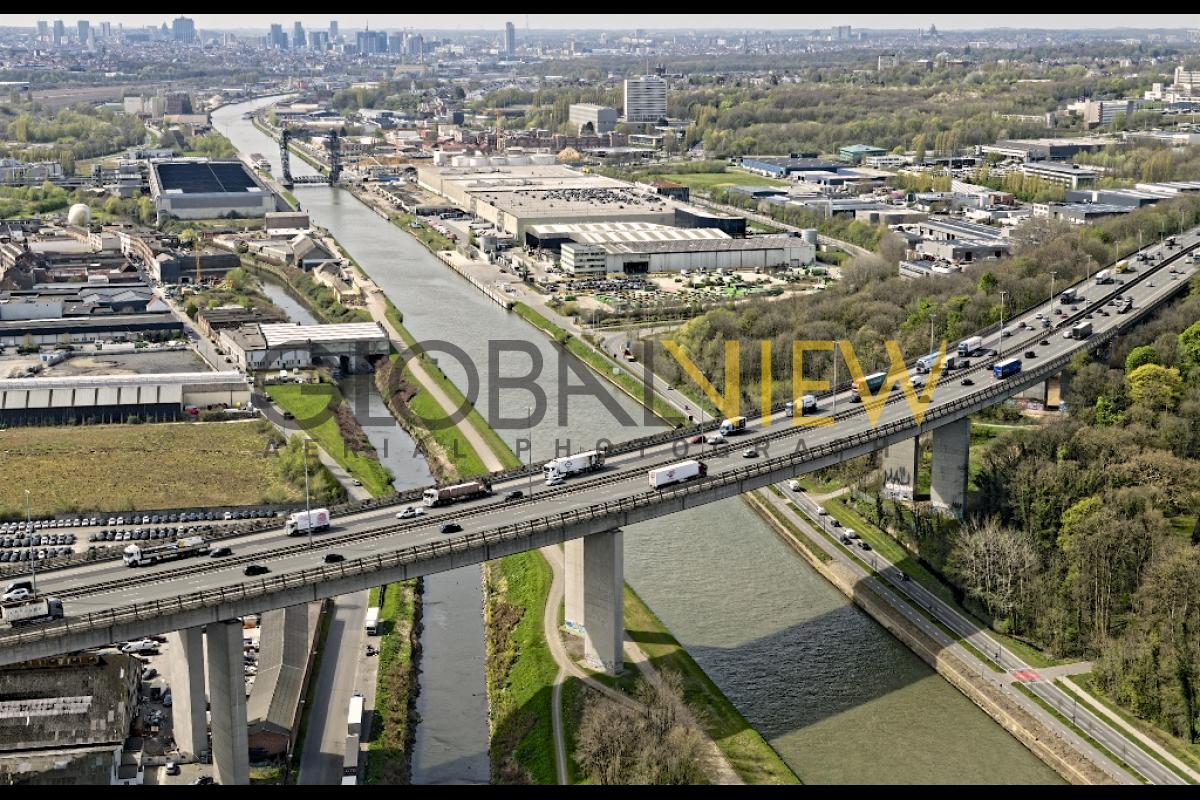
[0, 12, 1200, 31]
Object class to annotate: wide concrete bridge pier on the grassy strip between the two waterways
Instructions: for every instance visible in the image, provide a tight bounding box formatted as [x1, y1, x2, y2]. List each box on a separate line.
[563, 530, 625, 675]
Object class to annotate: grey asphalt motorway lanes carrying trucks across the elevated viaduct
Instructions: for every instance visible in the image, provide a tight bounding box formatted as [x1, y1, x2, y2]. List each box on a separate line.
[7, 230, 1200, 660]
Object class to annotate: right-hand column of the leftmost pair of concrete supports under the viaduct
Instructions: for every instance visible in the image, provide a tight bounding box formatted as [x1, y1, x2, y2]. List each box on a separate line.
[208, 619, 250, 786]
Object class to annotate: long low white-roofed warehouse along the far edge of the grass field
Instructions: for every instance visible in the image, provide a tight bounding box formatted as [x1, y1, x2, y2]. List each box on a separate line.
[0, 372, 250, 426]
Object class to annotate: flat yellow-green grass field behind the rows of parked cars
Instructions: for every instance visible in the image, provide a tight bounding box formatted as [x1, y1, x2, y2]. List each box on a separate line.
[0, 421, 304, 516]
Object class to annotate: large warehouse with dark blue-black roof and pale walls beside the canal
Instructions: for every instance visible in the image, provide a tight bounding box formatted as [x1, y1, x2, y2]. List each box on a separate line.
[150, 158, 276, 219]
